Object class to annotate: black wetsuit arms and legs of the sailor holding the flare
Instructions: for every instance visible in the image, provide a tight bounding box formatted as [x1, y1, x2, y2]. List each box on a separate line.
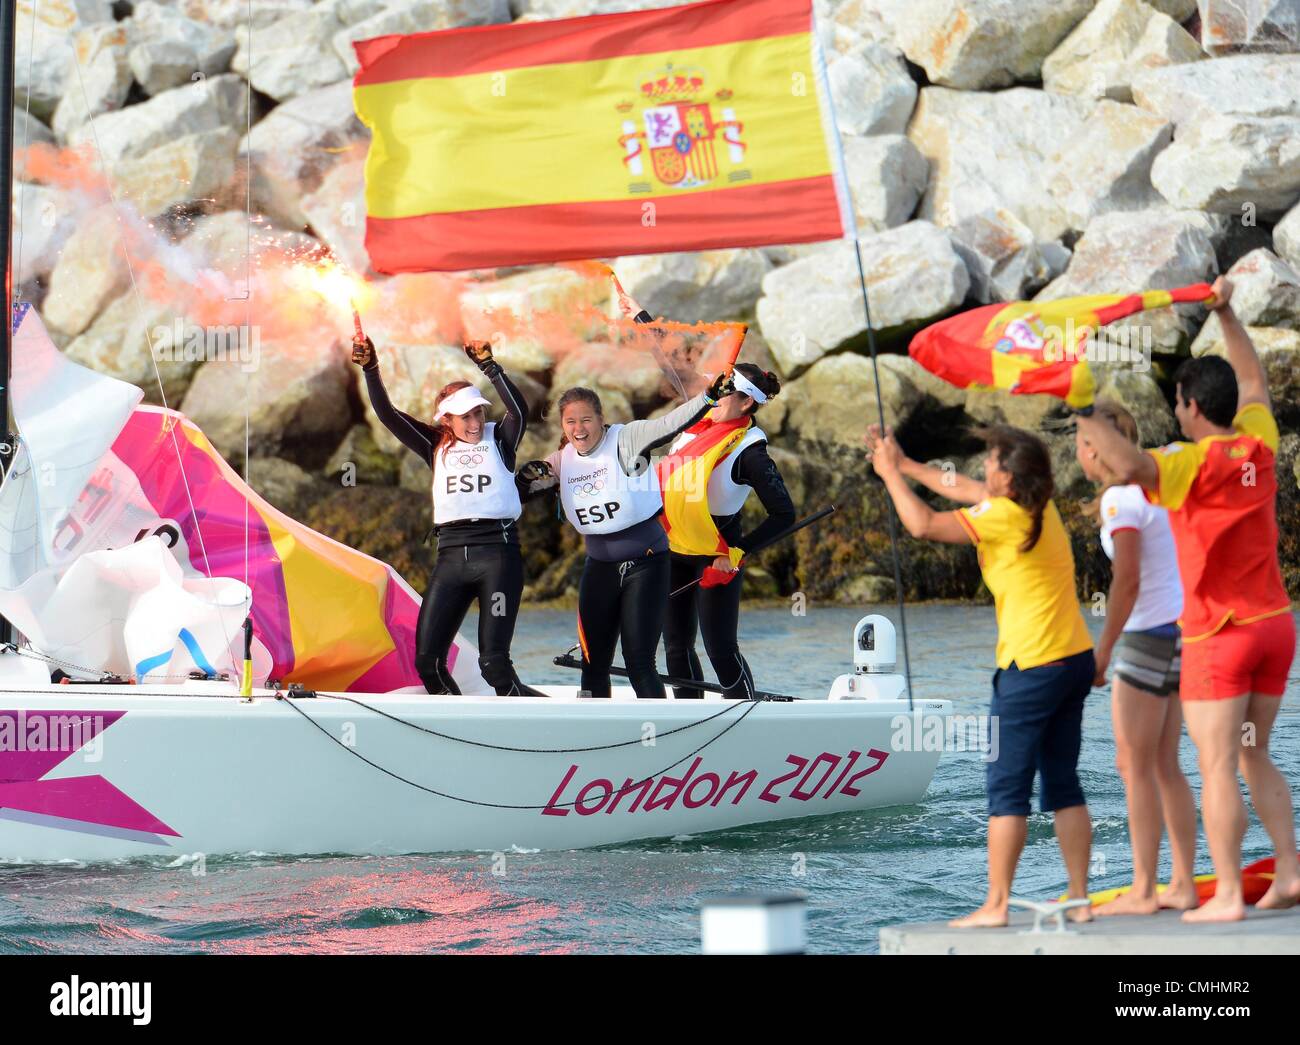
[364, 361, 534, 697]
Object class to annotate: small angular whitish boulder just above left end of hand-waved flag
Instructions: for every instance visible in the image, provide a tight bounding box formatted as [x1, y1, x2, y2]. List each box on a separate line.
[950, 208, 1070, 304]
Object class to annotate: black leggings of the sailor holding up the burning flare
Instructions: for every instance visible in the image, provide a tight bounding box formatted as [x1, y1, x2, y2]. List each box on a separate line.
[415, 543, 533, 697]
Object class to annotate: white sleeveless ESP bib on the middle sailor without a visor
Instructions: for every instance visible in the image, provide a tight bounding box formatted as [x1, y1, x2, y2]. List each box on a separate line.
[559, 425, 663, 534]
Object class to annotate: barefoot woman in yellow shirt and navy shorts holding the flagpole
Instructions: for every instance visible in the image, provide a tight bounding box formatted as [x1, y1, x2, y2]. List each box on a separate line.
[867, 425, 1096, 928]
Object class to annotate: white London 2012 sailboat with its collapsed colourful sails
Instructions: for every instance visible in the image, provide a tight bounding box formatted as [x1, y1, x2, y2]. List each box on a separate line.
[0, 296, 948, 860]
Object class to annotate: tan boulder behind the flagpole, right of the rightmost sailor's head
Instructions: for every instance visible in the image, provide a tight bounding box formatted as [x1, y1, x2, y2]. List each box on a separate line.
[781, 352, 926, 450]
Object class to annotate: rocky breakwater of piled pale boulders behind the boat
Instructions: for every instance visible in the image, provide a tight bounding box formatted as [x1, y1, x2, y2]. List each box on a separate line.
[14, 0, 1300, 603]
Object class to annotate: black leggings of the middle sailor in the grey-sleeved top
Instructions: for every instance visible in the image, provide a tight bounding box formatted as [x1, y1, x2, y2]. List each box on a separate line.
[577, 554, 668, 698]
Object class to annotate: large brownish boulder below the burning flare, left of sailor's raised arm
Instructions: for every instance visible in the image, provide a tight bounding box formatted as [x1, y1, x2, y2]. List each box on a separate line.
[182, 339, 352, 465]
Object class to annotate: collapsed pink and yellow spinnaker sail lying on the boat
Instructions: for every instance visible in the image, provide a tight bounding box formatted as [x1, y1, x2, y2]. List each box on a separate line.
[112, 407, 423, 693]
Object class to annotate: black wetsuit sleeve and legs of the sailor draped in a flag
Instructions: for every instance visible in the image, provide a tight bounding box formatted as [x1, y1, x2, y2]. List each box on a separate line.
[664, 441, 794, 699]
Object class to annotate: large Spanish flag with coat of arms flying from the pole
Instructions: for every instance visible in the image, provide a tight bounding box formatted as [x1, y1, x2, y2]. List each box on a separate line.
[355, 0, 853, 273]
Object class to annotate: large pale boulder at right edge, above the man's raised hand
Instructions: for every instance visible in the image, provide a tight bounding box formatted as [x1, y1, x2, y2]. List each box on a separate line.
[1151, 112, 1300, 220]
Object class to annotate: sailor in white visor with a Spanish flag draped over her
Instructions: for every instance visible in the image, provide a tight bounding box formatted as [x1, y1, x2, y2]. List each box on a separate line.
[660, 363, 794, 698]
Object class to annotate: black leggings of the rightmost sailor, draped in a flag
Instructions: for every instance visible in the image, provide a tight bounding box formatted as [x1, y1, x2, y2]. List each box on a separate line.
[664, 555, 754, 701]
